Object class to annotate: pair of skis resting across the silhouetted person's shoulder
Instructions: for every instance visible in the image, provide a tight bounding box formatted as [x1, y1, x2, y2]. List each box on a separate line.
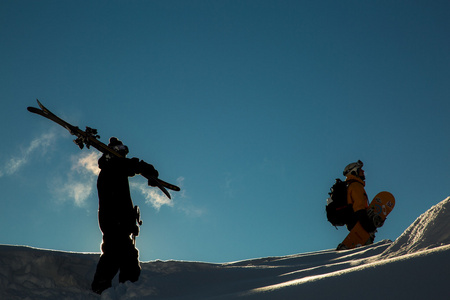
[27, 99, 180, 199]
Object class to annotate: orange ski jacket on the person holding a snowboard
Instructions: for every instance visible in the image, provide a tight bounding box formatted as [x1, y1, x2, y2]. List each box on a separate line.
[346, 175, 376, 233]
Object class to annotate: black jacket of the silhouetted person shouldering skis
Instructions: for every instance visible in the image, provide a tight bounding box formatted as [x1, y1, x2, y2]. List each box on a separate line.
[97, 155, 158, 234]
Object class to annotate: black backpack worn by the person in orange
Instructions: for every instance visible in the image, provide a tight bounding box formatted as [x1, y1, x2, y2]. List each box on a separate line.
[325, 178, 353, 226]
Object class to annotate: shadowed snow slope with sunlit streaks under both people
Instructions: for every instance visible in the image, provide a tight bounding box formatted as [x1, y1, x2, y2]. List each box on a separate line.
[0, 197, 450, 300]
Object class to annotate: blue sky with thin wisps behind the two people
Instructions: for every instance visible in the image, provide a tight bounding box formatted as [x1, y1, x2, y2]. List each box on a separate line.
[0, 0, 450, 262]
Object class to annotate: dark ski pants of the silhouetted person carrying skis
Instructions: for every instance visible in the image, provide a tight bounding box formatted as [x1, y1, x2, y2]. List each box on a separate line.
[92, 234, 141, 290]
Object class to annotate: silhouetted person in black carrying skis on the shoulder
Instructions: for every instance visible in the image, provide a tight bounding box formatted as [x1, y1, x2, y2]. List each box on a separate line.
[91, 137, 158, 294]
